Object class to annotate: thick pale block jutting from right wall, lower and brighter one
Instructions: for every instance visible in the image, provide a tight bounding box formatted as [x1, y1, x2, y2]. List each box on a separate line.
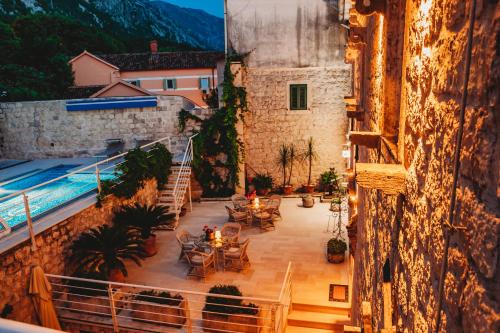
[356, 163, 407, 195]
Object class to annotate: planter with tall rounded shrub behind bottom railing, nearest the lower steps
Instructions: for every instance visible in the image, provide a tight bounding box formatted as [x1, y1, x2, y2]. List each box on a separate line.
[202, 285, 261, 333]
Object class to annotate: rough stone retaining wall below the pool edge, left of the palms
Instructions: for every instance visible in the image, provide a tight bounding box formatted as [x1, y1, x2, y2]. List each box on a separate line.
[0, 180, 158, 324]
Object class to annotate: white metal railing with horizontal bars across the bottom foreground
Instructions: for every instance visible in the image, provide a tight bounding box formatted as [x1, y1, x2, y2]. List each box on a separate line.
[46, 264, 292, 333]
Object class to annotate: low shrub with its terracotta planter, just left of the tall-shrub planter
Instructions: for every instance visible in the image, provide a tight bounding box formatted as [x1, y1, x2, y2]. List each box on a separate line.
[131, 290, 187, 328]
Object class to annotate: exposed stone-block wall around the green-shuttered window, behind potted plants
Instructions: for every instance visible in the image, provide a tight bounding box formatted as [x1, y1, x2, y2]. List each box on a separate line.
[244, 65, 351, 188]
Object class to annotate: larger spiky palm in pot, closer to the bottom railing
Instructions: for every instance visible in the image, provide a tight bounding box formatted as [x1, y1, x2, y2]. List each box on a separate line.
[70, 225, 146, 282]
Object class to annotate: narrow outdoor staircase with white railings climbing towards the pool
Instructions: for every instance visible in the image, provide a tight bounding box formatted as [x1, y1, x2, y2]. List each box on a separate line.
[157, 134, 197, 230]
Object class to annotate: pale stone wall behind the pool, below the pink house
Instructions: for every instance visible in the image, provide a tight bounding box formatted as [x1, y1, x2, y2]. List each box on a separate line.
[0, 96, 204, 159]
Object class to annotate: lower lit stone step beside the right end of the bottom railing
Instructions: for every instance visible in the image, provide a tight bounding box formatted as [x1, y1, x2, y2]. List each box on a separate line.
[288, 310, 351, 332]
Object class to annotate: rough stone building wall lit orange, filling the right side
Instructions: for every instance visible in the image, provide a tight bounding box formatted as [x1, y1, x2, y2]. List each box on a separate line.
[353, 0, 500, 332]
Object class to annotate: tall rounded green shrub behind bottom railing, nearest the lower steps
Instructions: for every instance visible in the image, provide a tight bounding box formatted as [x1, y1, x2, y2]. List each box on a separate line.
[203, 284, 259, 315]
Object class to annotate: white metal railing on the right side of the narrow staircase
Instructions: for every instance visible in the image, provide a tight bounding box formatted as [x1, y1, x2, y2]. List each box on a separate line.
[172, 134, 198, 219]
